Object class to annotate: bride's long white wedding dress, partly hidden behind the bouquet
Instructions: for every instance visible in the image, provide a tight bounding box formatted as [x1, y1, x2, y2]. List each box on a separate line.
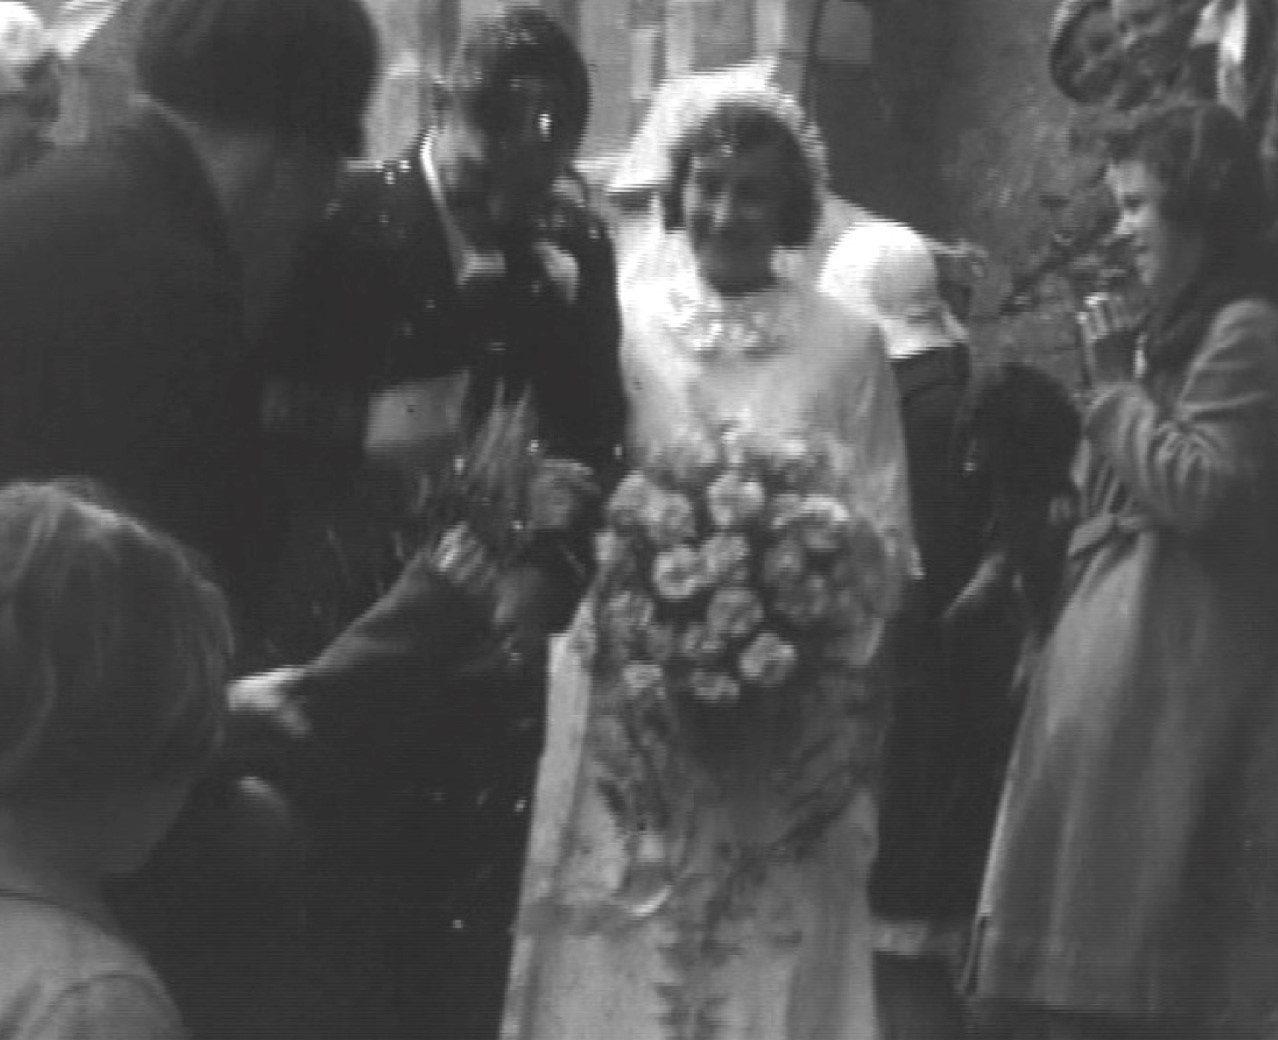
[502, 264, 914, 1040]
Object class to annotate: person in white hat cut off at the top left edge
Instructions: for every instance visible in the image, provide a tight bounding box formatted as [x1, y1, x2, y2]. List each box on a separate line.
[0, 0, 63, 180]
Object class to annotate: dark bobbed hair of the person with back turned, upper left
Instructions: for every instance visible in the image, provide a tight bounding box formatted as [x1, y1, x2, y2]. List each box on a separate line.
[137, 0, 377, 156]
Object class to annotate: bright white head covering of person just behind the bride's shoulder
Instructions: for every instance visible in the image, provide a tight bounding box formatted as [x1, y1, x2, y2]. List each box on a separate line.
[818, 221, 967, 360]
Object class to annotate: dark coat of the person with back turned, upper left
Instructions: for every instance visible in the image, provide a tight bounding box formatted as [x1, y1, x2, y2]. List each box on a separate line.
[0, 104, 265, 603]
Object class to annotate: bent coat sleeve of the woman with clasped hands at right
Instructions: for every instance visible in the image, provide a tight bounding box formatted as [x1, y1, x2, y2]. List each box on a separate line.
[1084, 300, 1278, 534]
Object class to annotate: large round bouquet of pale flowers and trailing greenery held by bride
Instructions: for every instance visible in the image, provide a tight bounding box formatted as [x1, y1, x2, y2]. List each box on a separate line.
[593, 431, 893, 858]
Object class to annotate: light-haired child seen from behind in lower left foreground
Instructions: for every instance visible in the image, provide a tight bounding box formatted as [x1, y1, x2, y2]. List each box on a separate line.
[0, 483, 231, 1040]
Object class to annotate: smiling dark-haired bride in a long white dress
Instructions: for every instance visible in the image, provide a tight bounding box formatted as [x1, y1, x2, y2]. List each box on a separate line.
[502, 89, 914, 1040]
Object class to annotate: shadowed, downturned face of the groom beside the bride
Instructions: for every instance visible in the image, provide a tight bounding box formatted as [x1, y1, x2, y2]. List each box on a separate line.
[440, 77, 576, 224]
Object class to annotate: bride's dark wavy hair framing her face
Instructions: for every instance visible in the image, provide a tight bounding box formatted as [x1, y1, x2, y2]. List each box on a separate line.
[661, 98, 820, 248]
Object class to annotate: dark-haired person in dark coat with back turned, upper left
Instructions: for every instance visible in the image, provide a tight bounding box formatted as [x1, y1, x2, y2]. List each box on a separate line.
[0, 0, 374, 1035]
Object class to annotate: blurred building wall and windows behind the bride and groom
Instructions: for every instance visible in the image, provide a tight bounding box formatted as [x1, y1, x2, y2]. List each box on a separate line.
[29, 0, 1088, 374]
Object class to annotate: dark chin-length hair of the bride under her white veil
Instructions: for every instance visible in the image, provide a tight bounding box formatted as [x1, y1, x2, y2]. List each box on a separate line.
[661, 92, 826, 248]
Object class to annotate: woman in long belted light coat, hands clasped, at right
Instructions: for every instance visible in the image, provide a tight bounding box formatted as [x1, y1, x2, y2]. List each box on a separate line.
[973, 103, 1278, 1040]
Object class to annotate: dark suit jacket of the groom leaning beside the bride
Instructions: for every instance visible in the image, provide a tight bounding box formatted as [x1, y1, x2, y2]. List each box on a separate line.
[256, 146, 625, 667]
